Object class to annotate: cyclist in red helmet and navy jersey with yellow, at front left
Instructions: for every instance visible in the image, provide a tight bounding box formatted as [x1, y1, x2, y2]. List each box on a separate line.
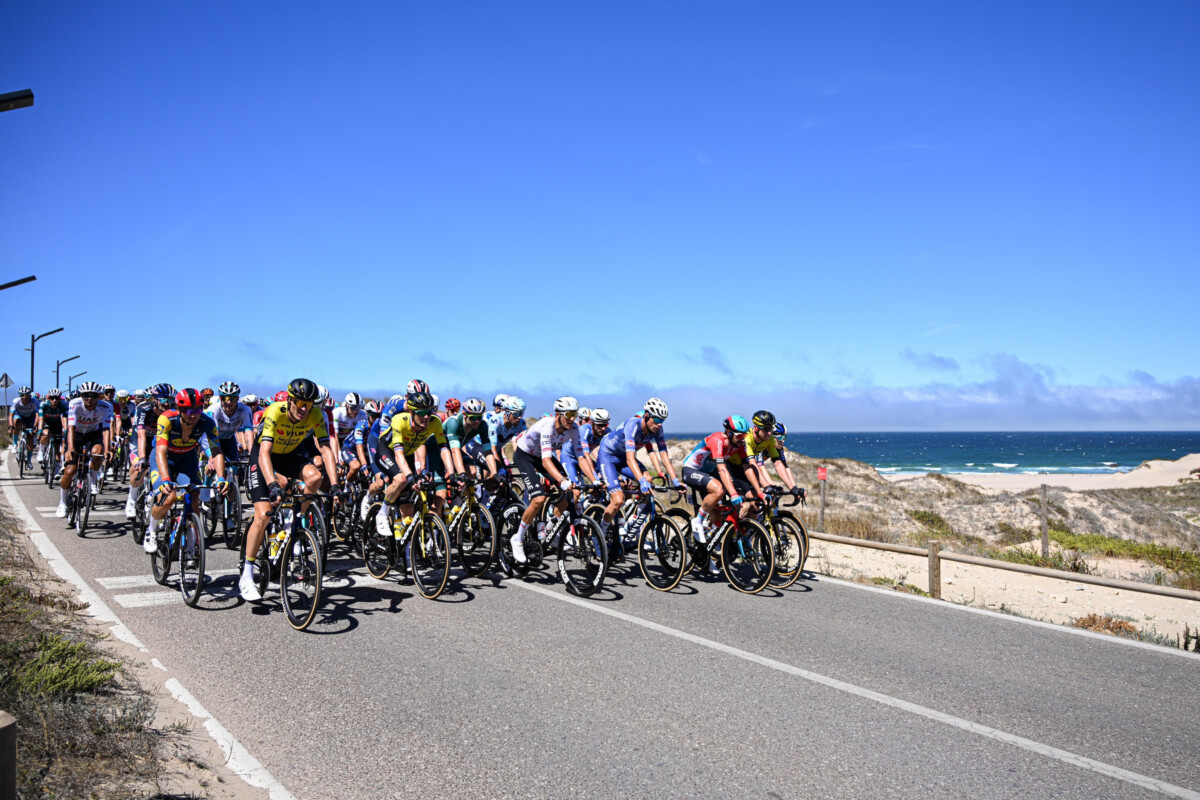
[142, 389, 229, 553]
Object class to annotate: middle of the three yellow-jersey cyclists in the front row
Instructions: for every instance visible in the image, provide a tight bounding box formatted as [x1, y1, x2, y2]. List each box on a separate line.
[374, 393, 450, 539]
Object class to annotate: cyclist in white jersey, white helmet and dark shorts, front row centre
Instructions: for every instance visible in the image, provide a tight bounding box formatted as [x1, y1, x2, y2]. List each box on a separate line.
[509, 397, 595, 564]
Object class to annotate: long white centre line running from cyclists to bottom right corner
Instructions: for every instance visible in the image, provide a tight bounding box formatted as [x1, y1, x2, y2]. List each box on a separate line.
[505, 581, 1200, 800]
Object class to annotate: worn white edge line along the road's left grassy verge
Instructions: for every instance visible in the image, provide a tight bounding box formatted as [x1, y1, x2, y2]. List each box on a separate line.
[0, 458, 295, 800]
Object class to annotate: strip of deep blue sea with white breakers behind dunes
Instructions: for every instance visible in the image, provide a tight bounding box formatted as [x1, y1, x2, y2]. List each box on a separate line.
[681, 431, 1200, 474]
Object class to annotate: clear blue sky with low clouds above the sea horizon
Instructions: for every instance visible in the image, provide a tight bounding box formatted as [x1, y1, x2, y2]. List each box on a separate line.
[0, 0, 1200, 431]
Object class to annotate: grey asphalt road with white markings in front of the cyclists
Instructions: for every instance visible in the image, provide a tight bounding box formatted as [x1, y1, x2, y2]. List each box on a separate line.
[0, 455, 1200, 800]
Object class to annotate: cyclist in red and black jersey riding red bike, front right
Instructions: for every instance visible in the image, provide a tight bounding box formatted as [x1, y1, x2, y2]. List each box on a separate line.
[683, 414, 760, 545]
